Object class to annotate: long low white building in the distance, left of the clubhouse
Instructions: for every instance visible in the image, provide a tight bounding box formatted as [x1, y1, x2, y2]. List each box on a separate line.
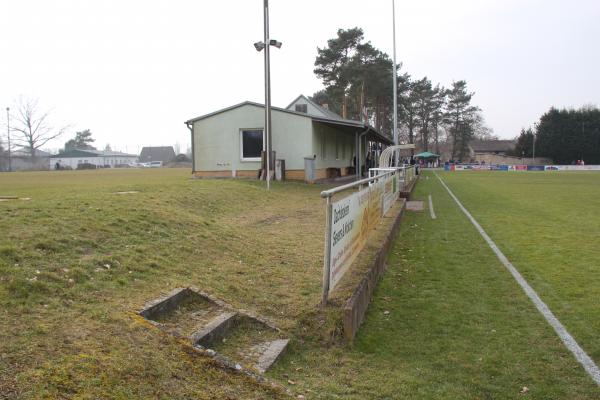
[48, 149, 138, 169]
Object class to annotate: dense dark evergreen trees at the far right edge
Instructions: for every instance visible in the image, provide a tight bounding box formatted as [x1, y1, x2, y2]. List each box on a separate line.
[514, 106, 600, 164]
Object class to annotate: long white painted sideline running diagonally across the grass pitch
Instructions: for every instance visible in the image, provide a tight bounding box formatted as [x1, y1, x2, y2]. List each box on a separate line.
[433, 171, 600, 385]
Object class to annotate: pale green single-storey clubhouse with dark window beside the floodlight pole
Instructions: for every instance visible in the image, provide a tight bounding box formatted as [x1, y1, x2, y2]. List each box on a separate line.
[186, 95, 392, 182]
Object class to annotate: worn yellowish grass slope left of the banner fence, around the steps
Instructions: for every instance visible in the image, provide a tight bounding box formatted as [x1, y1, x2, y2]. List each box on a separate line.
[0, 169, 324, 399]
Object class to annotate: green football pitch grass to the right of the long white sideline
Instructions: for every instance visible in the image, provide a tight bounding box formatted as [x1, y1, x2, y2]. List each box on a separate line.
[441, 172, 600, 368]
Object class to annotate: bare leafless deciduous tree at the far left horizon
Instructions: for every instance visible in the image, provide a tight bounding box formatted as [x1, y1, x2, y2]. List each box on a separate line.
[11, 98, 67, 157]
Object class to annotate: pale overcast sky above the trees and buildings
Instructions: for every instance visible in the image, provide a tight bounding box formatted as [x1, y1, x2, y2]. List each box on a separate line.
[0, 0, 600, 152]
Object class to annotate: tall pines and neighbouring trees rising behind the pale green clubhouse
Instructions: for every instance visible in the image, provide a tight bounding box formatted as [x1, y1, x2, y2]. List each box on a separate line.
[312, 28, 491, 159]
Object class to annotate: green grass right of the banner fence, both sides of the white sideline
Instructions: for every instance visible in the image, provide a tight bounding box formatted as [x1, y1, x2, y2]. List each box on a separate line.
[278, 172, 600, 399]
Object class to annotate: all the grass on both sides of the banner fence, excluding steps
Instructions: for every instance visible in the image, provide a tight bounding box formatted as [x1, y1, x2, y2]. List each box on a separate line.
[0, 169, 600, 399]
